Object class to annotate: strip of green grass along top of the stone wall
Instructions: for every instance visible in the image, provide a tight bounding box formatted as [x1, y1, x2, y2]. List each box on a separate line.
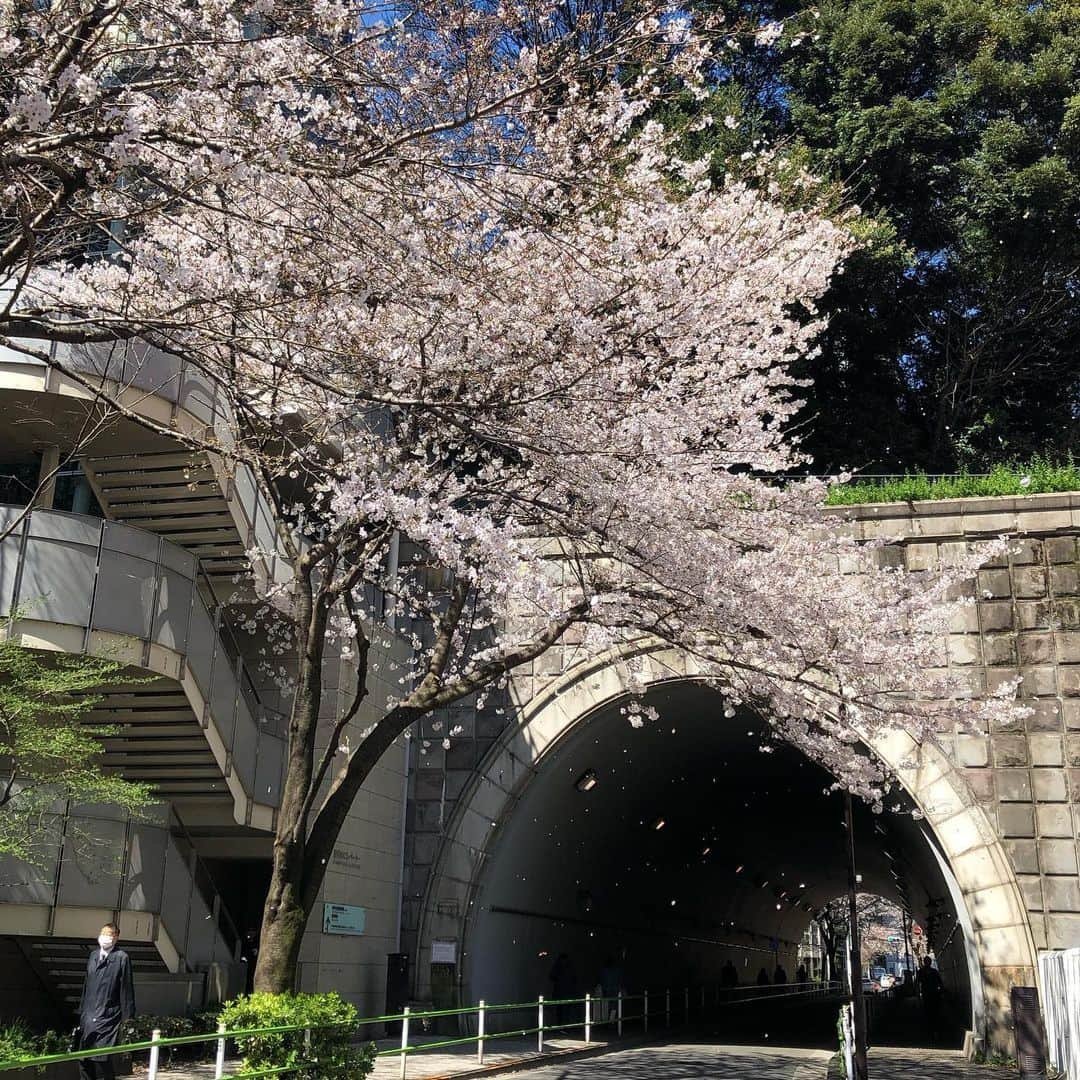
[825, 455, 1080, 507]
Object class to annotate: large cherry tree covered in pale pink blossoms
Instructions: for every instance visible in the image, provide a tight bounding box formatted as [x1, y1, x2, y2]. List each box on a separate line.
[0, 0, 1007, 990]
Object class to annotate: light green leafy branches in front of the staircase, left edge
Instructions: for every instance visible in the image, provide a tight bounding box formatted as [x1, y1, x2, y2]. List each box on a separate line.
[0, 638, 153, 863]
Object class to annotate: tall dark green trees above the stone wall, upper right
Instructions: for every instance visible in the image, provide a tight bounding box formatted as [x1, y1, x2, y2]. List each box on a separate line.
[686, 0, 1080, 472]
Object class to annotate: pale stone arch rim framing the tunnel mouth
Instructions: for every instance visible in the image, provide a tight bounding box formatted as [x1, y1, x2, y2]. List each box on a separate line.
[416, 645, 1038, 1048]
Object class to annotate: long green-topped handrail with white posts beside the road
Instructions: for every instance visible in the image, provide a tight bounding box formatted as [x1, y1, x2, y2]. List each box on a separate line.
[0, 982, 840, 1080]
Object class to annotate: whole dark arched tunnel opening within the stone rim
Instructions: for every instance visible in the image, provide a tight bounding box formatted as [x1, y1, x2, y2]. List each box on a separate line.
[462, 680, 978, 1041]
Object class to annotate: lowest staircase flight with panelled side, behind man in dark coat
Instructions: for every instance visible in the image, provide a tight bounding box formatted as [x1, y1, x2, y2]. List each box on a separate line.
[0, 807, 244, 1013]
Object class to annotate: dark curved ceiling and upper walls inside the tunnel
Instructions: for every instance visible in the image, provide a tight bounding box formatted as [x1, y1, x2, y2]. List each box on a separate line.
[478, 681, 955, 954]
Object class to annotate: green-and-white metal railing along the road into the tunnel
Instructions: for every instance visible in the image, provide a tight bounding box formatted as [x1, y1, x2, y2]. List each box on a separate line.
[0, 983, 842, 1080]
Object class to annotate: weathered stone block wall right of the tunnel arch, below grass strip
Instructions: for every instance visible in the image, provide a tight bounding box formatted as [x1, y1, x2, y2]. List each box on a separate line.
[846, 492, 1080, 949]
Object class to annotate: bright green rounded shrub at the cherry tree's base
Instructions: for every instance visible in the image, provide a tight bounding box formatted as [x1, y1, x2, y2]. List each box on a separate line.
[220, 994, 375, 1080]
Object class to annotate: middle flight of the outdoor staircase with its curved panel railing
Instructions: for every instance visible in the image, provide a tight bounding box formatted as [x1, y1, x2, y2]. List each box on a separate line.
[0, 507, 285, 829]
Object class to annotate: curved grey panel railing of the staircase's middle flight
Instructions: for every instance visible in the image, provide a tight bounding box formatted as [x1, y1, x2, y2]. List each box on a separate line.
[0, 507, 285, 807]
